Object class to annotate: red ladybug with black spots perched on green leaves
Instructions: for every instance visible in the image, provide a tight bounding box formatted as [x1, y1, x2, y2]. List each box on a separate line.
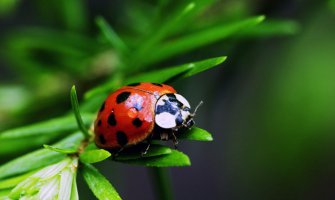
[94, 82, 202, 150]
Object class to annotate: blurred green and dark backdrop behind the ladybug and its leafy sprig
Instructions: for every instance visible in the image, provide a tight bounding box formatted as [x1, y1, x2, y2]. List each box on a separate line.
[0, 0, 335, 199]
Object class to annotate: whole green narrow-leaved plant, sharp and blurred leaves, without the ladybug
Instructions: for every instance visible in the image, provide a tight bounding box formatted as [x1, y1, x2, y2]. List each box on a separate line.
[0, 0, 296, 199]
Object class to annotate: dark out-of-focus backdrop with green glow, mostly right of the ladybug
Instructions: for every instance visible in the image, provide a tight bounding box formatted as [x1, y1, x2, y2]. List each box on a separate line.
[0, 1, 335, 199]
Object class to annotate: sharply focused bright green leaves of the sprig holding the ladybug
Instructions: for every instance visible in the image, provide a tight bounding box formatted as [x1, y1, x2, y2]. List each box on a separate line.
[0, 57, 226, 199]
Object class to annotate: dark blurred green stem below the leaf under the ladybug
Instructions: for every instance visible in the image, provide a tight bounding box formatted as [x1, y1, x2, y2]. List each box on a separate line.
[149, 167, 173, 200]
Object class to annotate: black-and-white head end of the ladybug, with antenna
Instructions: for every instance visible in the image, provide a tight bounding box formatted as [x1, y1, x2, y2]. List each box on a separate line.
[155, 93, 202, 130]
